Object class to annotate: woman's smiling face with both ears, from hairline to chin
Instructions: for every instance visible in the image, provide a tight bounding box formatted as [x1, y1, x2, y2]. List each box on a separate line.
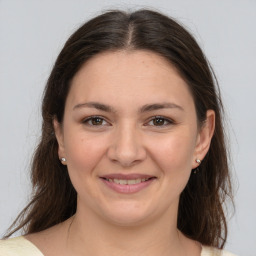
[54, 51, 214, 225]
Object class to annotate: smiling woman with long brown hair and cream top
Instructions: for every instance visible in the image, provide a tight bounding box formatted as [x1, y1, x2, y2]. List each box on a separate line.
[0, 10, 236, 256]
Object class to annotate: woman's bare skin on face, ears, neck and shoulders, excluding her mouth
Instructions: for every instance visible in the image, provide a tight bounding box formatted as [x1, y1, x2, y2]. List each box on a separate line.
[27, 51, 214, 256]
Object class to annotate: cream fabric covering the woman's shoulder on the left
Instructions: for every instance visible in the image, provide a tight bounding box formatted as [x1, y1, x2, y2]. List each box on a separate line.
[0, 236, 43, 256]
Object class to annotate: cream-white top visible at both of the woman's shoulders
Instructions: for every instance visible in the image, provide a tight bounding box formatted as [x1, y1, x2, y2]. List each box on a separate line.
[0, 236, 238, 256]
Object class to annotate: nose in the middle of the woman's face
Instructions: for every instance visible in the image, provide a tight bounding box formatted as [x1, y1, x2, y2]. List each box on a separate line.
[107, 124, 147, 167]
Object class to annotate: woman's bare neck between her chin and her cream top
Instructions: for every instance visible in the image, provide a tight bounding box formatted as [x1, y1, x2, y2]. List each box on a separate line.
[67, 202, 192, 256]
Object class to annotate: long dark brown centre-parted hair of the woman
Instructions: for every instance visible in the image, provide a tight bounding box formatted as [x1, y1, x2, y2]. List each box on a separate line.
[6, 10, 232, 248]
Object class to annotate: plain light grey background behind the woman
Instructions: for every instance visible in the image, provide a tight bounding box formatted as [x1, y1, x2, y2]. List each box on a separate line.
[0, 0, 256, 256]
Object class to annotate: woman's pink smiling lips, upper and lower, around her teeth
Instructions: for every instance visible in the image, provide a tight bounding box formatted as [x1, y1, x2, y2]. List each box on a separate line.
[100, 174, 156, 194]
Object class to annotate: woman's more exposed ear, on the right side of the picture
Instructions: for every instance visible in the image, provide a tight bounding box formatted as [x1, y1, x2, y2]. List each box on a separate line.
[192, 110, 215, 169]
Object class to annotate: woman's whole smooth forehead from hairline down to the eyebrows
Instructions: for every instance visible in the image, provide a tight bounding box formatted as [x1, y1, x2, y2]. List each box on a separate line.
[65, 50, 193, 112]
